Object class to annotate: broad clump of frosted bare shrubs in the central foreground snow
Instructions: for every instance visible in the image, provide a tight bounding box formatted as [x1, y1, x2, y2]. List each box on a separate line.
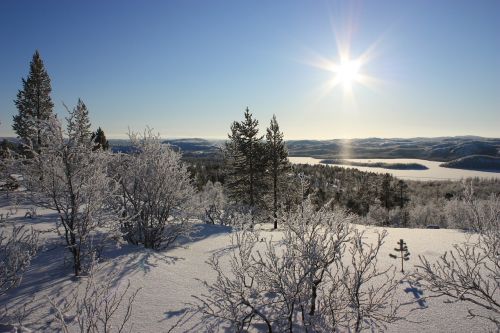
[193, 198, 397, 332]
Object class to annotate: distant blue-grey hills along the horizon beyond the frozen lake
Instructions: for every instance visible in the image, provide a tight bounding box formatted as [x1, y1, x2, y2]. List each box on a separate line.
[5, 136, 494, 161]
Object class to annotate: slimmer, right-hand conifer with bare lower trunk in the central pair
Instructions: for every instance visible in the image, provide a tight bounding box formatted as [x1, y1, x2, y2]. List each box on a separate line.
[266, 115, 290, 229]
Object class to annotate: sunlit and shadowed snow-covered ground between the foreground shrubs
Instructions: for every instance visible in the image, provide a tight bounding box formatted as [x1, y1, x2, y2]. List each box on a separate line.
[0, 193, 493, 332]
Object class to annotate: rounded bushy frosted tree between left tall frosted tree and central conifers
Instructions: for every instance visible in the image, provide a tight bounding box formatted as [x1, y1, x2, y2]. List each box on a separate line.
[114, 129, 194, 249]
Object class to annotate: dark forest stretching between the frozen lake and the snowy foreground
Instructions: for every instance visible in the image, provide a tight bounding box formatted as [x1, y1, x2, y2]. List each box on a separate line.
[187, 148, 500, 228]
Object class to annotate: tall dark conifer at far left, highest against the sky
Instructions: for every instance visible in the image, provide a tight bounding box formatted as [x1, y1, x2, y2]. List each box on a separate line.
[12, 50, 54, 150]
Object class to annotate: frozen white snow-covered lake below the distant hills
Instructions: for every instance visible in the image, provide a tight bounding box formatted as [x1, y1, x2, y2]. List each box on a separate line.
[288, 157, 500, 180]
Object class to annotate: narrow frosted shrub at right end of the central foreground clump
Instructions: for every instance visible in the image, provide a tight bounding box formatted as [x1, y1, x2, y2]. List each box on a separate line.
[328, 229, 402, 332]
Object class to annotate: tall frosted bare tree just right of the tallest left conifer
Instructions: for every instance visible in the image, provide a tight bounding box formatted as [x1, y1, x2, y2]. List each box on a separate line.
[21, 101, 113, 275]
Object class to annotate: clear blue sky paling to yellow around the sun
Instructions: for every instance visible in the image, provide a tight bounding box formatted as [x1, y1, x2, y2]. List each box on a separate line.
[0, 0, 500, 139]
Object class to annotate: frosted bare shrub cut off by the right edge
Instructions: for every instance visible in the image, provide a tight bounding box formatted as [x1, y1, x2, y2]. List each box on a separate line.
[416, 188, 500, 330]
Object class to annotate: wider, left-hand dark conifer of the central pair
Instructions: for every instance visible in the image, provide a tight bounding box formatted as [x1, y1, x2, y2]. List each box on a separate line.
[225, 108, 266, 208]
